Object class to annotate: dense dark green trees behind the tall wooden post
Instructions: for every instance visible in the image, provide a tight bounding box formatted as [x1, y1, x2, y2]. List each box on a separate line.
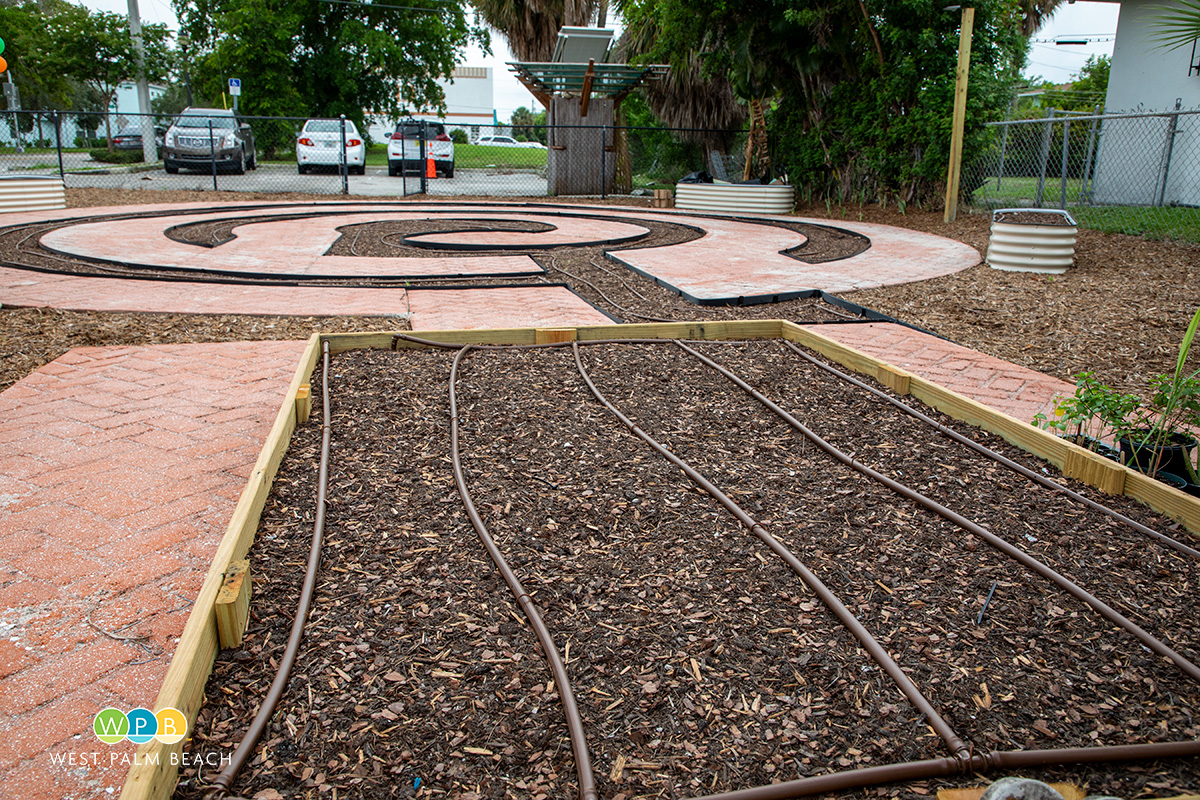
[626, 0, 1040, 201]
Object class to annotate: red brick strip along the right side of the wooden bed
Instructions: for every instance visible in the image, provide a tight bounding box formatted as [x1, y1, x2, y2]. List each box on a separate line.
[810, 323, 1075, 422]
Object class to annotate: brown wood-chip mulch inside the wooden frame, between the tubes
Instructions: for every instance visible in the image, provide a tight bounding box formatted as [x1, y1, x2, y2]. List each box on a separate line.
[176, 342, 1200, 800]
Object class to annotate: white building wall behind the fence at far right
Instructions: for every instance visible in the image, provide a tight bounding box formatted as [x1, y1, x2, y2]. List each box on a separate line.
[1092, 0, 1200, 206]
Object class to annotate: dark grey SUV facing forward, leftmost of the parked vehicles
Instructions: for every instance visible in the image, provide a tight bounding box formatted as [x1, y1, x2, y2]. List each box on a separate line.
[162, 108, 258, 175]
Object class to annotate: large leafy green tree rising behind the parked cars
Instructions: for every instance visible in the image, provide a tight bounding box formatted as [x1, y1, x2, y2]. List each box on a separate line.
[173, 0, 488, 127]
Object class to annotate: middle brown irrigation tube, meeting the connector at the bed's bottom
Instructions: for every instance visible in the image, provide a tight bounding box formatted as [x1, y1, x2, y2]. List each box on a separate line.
[571, 342, 970, 758]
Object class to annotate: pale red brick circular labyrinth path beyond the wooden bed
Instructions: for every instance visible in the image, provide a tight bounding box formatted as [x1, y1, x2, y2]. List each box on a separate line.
[0, 203, 979, 319]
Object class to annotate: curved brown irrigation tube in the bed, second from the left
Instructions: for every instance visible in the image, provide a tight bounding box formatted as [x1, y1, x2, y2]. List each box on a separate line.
[450, 344, 596, 800]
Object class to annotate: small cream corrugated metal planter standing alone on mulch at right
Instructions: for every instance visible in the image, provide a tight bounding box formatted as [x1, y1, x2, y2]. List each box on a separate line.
[988, 209, 1079, 275]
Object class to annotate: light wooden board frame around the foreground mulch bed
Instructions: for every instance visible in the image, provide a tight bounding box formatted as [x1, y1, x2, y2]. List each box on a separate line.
[121, 319, 1200, 800]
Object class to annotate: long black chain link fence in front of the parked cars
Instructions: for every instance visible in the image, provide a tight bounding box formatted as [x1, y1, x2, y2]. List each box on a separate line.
[0, 109, 746, 198]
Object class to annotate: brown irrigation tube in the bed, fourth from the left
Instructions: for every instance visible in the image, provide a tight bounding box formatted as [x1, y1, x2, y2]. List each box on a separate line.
[676, 341, 1200, 682]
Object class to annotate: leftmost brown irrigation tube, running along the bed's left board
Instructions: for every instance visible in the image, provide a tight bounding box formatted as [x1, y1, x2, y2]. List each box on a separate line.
[204, 342, 330, 800]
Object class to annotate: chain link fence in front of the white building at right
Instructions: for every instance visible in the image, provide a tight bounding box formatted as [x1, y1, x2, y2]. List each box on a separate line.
[964, 109, 1200, 241]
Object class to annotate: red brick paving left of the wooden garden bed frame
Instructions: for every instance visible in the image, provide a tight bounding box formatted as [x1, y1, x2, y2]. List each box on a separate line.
[0, 342, 304, 800]
